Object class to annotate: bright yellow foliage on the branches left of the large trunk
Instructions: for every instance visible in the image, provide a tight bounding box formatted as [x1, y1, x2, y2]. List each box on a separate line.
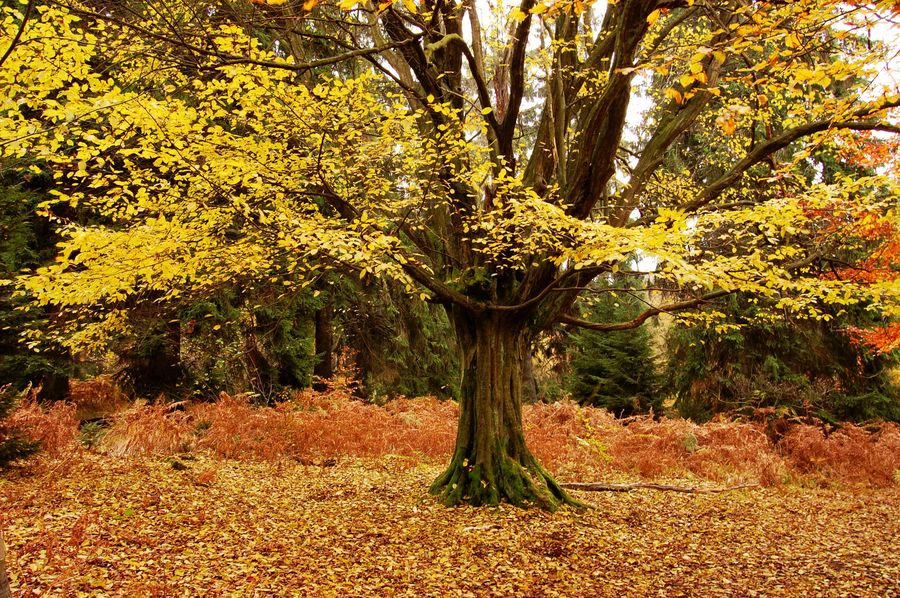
[0, 7, 442, 352]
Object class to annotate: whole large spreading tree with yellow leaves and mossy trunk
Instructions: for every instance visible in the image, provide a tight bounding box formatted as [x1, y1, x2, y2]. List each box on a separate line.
[0, 0, 900, 508]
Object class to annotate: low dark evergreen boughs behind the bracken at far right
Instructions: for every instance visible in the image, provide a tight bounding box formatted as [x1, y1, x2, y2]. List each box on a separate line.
[666, 296, 900, 421]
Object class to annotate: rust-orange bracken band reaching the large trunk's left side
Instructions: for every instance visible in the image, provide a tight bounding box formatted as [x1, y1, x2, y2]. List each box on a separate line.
[98, 390, 456, 463]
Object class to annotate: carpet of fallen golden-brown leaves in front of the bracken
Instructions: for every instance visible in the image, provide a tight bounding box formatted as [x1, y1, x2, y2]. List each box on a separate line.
[0, 453, 900, 596]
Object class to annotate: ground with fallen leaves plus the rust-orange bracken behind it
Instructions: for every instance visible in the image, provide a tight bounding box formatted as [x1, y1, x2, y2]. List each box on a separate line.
[0, 383, 900, 597]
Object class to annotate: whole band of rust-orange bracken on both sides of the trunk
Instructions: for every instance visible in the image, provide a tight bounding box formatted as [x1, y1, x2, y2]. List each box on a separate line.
[3, 385, 900, 487]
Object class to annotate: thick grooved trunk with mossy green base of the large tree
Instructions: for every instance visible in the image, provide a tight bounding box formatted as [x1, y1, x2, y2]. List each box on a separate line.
[431, 312, 577, 510]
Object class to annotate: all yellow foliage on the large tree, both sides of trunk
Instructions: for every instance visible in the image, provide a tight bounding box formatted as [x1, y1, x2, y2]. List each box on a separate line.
[0, 0, 890, 352]
